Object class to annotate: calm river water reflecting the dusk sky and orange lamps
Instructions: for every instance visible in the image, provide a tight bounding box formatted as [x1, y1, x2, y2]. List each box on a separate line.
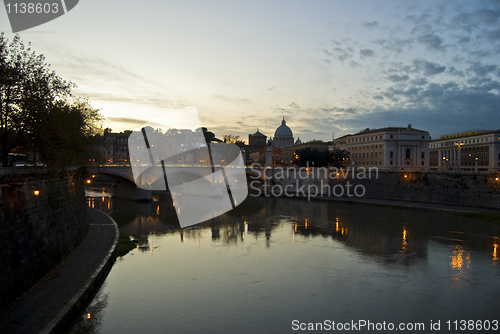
[72, 188, 500, 333]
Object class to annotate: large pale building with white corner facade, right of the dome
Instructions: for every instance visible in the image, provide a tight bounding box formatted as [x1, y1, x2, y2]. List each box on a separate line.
[333, 124, 431, 170]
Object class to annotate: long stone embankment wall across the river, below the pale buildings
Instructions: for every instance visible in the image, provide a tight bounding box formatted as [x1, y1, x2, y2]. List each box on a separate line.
[256, 169, 500, 209]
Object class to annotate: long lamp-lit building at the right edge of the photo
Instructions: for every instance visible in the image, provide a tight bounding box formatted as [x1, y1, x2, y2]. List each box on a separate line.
[429, 130, 500, 171]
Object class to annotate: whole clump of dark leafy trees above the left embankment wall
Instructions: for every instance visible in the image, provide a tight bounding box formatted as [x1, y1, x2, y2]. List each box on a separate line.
[0, 33, 102, 170]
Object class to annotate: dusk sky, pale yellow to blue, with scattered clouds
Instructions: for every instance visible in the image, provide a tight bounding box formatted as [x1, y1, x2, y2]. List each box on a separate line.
[0, 0, 500, 142]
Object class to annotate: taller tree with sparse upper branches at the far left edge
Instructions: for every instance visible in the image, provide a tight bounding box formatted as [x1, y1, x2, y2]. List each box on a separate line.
[0, 33, 74, 163]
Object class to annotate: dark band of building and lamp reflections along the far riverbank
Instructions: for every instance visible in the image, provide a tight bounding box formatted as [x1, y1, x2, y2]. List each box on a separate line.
[83, 188, 499, 270]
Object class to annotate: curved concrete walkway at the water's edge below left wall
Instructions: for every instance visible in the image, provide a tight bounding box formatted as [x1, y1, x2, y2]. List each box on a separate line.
[0, 209, 119, 333]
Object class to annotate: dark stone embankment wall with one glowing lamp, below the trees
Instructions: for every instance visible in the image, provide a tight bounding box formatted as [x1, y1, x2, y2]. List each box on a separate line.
[0, 168, 89, 306]
